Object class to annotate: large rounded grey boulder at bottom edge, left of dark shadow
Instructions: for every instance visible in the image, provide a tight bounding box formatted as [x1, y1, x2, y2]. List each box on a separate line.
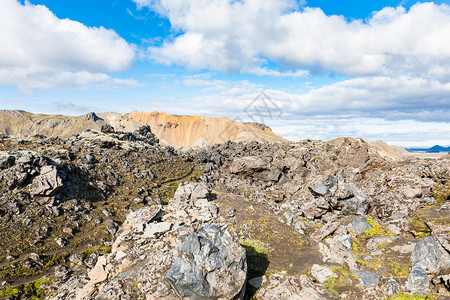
[166, 224, 247, 300]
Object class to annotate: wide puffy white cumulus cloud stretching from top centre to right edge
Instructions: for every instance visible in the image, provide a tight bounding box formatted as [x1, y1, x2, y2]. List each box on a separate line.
[133, 0, 450, 80]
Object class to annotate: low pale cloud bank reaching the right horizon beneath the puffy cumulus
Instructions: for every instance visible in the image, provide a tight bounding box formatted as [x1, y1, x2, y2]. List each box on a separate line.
[132, 74, 450, 146]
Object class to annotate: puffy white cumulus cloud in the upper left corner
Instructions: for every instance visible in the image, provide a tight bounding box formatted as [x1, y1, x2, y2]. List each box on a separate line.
[0, 0, 136, 90]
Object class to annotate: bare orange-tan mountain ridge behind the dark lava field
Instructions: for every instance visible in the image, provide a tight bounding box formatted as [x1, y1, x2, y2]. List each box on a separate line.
[0, 110, 284, 147]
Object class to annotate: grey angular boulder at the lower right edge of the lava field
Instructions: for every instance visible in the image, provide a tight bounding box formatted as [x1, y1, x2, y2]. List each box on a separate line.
[411, 236, 450, 274]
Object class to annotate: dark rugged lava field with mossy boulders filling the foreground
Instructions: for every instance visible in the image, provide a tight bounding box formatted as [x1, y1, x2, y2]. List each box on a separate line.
[0, 126, 450, 300]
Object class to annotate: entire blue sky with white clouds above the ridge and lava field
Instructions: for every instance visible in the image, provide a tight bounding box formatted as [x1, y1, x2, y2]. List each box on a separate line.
[0, 0, 450, 147]
